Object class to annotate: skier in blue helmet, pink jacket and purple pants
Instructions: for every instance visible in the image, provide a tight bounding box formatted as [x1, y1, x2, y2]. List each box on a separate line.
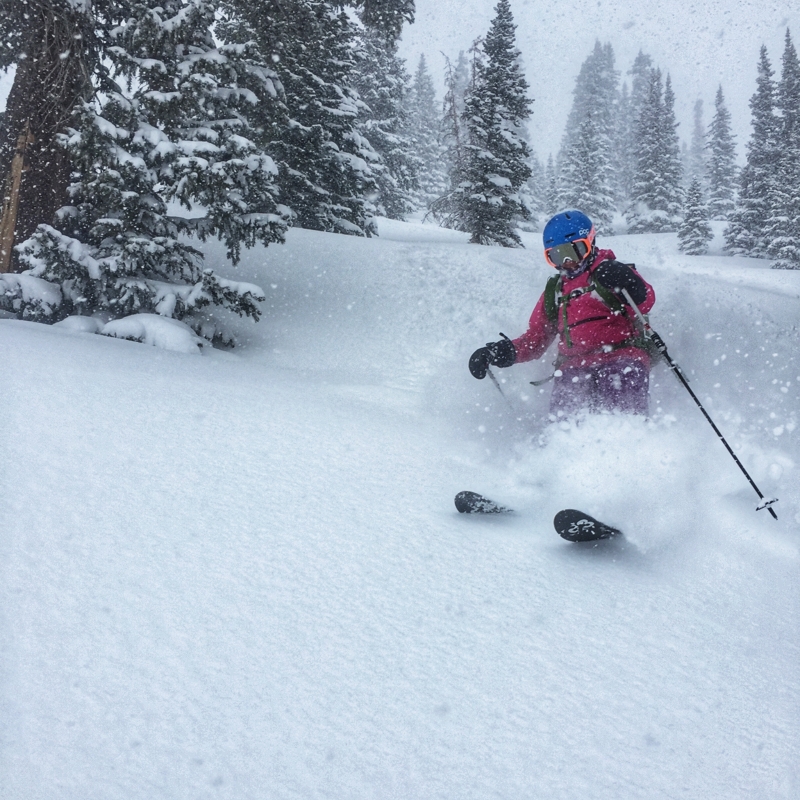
[469, 210, 655, 416]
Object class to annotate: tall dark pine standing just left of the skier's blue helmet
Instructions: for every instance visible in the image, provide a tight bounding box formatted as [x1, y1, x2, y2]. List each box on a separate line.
[460, 0, 531, 247]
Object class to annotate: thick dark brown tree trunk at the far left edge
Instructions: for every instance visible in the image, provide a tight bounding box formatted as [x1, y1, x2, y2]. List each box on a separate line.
[0, 0, 90, 268]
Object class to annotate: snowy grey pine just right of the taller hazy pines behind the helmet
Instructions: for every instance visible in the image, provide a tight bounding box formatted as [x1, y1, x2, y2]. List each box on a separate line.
[625, 69, 683, 233]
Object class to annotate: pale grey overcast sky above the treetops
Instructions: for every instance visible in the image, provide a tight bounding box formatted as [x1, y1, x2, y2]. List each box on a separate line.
[401, 0, 800, 160]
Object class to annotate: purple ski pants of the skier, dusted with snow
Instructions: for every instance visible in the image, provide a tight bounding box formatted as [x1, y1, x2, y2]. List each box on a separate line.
[550, 356, 650, 416]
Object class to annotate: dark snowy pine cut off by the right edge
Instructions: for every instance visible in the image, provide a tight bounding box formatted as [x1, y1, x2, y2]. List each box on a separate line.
[767, 30, 800, 269]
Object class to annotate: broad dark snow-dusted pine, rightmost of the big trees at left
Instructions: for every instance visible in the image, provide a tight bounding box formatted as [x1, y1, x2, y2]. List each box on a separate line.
[220, 0, 380, 236]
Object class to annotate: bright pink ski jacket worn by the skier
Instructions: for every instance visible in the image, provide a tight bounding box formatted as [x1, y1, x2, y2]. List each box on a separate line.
[513, 250, 656, 369]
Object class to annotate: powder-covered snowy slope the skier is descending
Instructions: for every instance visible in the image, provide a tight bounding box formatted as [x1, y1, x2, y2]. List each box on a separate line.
[0, 222, 800, 800]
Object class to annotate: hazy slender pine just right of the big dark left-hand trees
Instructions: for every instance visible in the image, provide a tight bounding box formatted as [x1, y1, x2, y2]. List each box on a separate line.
[409, 55, 447, 208]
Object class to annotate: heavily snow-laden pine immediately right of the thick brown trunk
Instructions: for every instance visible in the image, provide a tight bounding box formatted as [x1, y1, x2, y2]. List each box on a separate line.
[120, 0, 288, 261]
